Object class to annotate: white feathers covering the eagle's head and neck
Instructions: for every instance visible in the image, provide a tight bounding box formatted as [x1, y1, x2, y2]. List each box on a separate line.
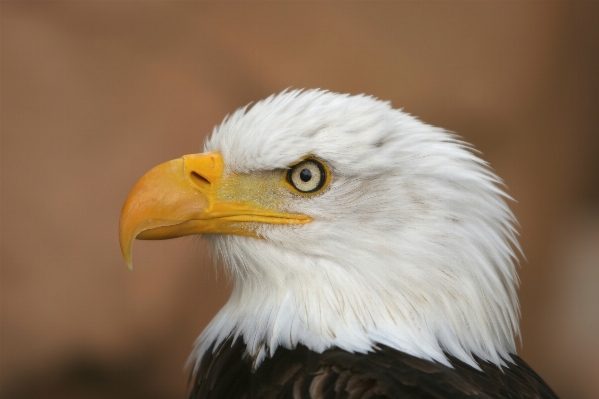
[192, 90, 519, 367]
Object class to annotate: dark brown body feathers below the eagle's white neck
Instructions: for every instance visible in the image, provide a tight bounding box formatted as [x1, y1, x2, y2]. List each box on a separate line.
[190, 338, 557, 399]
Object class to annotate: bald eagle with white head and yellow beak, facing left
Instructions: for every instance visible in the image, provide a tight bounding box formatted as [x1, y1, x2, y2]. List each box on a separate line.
[120, 90, 557, 399]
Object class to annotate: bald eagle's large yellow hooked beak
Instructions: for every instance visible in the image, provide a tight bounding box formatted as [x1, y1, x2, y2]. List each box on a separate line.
[119, 152, 312, 269]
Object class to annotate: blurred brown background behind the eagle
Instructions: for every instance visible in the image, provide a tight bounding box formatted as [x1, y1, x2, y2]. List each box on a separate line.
[0, 1, 599, 399]
